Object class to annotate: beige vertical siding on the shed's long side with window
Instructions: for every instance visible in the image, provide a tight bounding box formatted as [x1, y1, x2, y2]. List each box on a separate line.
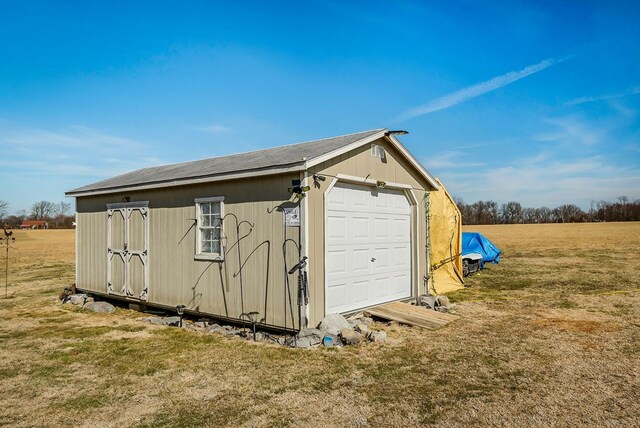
[77, 174, 299, 327]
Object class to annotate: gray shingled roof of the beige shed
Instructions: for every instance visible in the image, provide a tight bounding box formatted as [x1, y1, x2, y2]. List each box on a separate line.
[66, 128, 384, 196]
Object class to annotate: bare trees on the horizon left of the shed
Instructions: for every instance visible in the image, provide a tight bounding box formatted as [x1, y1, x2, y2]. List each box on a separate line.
[0, 199, 75, 228]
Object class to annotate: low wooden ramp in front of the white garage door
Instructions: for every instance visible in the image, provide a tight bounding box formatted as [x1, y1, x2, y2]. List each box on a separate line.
[364, 302, 458, 329]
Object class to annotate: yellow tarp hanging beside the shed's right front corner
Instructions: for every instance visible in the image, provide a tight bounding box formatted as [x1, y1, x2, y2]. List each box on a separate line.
[429, 178, 463, 294]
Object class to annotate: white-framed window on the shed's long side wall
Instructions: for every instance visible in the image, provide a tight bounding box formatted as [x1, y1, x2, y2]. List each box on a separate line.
[196, 197, 224, 260]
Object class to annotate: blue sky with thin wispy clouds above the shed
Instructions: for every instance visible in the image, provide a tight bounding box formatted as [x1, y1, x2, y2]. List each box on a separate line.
[0, 0, 640, 213]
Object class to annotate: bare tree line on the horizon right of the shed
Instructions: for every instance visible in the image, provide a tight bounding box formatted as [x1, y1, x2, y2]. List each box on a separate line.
[454, 196, 640, 224]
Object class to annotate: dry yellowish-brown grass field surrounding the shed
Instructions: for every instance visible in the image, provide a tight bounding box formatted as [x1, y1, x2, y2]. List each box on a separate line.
[0, 223, 640, 428]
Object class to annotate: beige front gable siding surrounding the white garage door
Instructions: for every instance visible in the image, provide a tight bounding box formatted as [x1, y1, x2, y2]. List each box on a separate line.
[308, 139, 431, 324]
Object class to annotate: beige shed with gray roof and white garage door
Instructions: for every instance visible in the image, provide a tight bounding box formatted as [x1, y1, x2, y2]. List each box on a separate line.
[66, 129, 459, 330]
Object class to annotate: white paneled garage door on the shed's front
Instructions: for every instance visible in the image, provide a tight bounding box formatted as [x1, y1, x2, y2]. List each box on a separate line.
[326, 183, 411, 313]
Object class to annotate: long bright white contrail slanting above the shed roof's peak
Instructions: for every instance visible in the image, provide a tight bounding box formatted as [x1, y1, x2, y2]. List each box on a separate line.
[399, 57, 569, 120]
